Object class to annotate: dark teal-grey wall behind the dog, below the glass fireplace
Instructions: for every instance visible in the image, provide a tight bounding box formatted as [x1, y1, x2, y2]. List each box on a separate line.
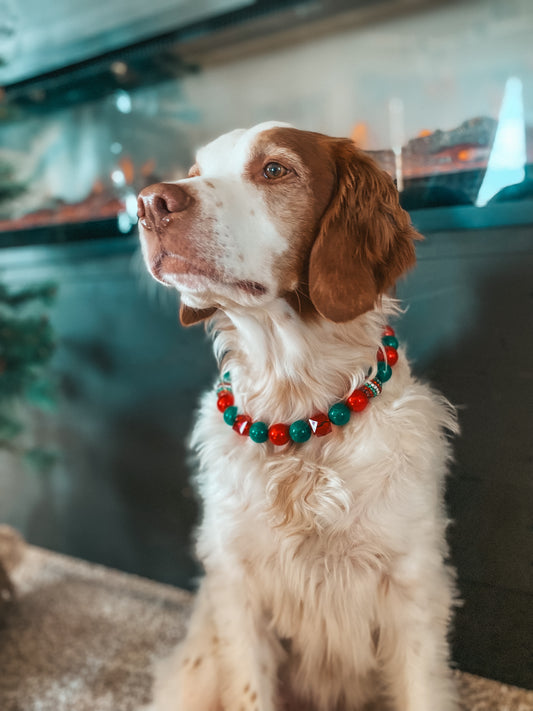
[0, 227, 533, 687]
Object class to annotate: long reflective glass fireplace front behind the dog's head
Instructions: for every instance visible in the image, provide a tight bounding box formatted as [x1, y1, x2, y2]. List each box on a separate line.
[0, 0, 533, 241]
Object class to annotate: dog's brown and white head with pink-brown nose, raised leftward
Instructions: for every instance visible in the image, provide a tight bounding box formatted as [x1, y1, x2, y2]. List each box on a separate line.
[138, 123, 419, 325]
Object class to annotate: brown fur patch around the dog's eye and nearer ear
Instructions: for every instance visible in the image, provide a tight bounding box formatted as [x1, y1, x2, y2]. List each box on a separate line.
[245, 128, 420, 322]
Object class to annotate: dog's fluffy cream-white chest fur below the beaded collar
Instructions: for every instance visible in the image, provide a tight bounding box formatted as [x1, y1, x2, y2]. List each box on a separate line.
[186, 363, 454, 707]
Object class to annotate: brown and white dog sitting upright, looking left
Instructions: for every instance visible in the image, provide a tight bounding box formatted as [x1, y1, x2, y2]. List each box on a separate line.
[139, 123, 457, 711]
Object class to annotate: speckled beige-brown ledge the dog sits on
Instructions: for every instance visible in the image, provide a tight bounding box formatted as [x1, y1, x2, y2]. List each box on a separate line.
[0, 546, 533, 711]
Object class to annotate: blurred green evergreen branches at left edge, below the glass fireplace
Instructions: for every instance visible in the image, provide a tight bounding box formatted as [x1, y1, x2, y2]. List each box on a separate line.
[0, 283, 57, 470]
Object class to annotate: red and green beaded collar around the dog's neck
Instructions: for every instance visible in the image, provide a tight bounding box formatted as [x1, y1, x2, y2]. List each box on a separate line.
[217, 326, 398, 447]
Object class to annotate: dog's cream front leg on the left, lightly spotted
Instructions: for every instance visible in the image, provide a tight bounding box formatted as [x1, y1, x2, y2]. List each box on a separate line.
[205, 569, 283, 711]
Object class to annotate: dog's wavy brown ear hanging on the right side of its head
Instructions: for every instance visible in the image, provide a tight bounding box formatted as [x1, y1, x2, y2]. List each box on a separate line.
[309, 139, 421, 322]
